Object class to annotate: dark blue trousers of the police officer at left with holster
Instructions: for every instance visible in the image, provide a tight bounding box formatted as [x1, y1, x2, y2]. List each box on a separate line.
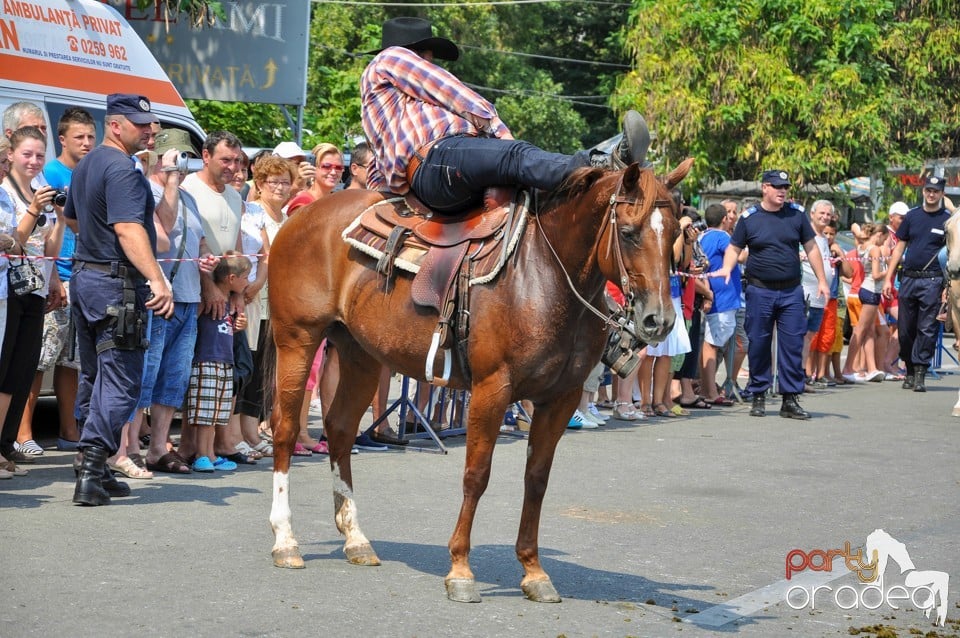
[70, 270, 147, 455]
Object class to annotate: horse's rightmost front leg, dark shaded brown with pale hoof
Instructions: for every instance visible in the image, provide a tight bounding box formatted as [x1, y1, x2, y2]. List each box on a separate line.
[516, 388, 581, 603]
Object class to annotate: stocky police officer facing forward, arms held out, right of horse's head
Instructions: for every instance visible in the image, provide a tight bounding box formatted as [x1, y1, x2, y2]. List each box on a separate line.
[714, 170, 830, 419]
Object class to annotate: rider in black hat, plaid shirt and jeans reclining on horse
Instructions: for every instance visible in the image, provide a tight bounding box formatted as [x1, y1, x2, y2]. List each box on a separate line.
[360, 18, 650, 213]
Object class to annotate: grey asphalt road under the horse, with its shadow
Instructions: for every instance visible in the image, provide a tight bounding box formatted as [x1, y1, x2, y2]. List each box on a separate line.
[0, 364, 960, 638]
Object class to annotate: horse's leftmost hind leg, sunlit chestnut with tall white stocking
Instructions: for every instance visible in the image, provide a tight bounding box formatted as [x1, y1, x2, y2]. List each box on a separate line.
[270, 339, 320, 569]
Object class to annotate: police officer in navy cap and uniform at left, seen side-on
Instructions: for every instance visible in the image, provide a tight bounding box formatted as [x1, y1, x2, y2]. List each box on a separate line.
[64, 93, 173, 505]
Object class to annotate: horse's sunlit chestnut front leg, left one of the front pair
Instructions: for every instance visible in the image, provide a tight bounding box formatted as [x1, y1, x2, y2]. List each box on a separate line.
[444, 378, 509, 603]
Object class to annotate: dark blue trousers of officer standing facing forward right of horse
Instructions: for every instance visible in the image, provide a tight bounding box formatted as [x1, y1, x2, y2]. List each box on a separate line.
[744, 285, 807, 395]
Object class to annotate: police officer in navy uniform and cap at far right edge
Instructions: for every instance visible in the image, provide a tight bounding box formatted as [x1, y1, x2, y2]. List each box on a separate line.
[883, 176, 950, 392]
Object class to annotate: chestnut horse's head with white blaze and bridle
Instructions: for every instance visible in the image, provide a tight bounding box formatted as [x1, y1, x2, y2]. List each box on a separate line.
[598, 158, 693, 343]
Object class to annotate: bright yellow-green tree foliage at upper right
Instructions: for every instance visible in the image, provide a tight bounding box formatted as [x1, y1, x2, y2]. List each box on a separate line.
[616, 0, 960, 188]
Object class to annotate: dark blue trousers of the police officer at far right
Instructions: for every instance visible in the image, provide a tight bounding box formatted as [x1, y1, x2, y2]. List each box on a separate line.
[897, 277, 943, 366]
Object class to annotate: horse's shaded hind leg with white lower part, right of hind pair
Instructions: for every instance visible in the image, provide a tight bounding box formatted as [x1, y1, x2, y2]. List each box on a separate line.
[323, 339, 381, 566]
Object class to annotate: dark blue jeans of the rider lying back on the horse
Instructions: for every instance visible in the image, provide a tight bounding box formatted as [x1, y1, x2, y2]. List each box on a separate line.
[411, 135, 590, 213]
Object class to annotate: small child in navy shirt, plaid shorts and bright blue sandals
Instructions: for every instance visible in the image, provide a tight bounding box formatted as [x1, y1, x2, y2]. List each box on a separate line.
[186, 250, 251, 472]
